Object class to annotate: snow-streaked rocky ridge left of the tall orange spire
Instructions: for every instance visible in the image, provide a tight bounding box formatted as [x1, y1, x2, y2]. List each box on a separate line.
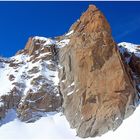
[0, 37, 62, 122]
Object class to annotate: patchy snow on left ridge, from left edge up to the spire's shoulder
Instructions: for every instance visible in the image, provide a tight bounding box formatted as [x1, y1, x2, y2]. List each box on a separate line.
[0, 35, 73, 96]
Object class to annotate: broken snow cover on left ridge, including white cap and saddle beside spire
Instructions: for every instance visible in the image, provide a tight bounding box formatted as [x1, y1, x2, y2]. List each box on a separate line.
[0, 30, 74, 95]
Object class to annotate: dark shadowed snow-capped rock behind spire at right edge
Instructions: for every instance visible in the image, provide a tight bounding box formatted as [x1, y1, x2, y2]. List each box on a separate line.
[118, 42, 140, 99]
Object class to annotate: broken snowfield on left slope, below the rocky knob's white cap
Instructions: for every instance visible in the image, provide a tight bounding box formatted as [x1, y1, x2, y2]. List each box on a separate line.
[0, 54, 59, 95]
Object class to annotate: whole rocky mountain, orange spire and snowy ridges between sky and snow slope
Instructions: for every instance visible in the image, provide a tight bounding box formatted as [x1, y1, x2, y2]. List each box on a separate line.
[0, 5, 140, 138]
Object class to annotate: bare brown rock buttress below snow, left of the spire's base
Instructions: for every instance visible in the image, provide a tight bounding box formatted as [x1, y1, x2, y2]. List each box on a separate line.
[18, 92, 61, 122]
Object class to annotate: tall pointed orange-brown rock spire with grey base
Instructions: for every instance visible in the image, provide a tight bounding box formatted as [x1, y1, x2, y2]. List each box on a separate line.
[59, 5, 135, 137]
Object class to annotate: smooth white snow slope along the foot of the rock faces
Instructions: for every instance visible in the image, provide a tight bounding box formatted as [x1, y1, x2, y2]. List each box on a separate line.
[0, 106, 140, 140]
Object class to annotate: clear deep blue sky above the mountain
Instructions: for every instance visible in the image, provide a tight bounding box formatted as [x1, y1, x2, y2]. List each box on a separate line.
[0, 2, 140, 57]
